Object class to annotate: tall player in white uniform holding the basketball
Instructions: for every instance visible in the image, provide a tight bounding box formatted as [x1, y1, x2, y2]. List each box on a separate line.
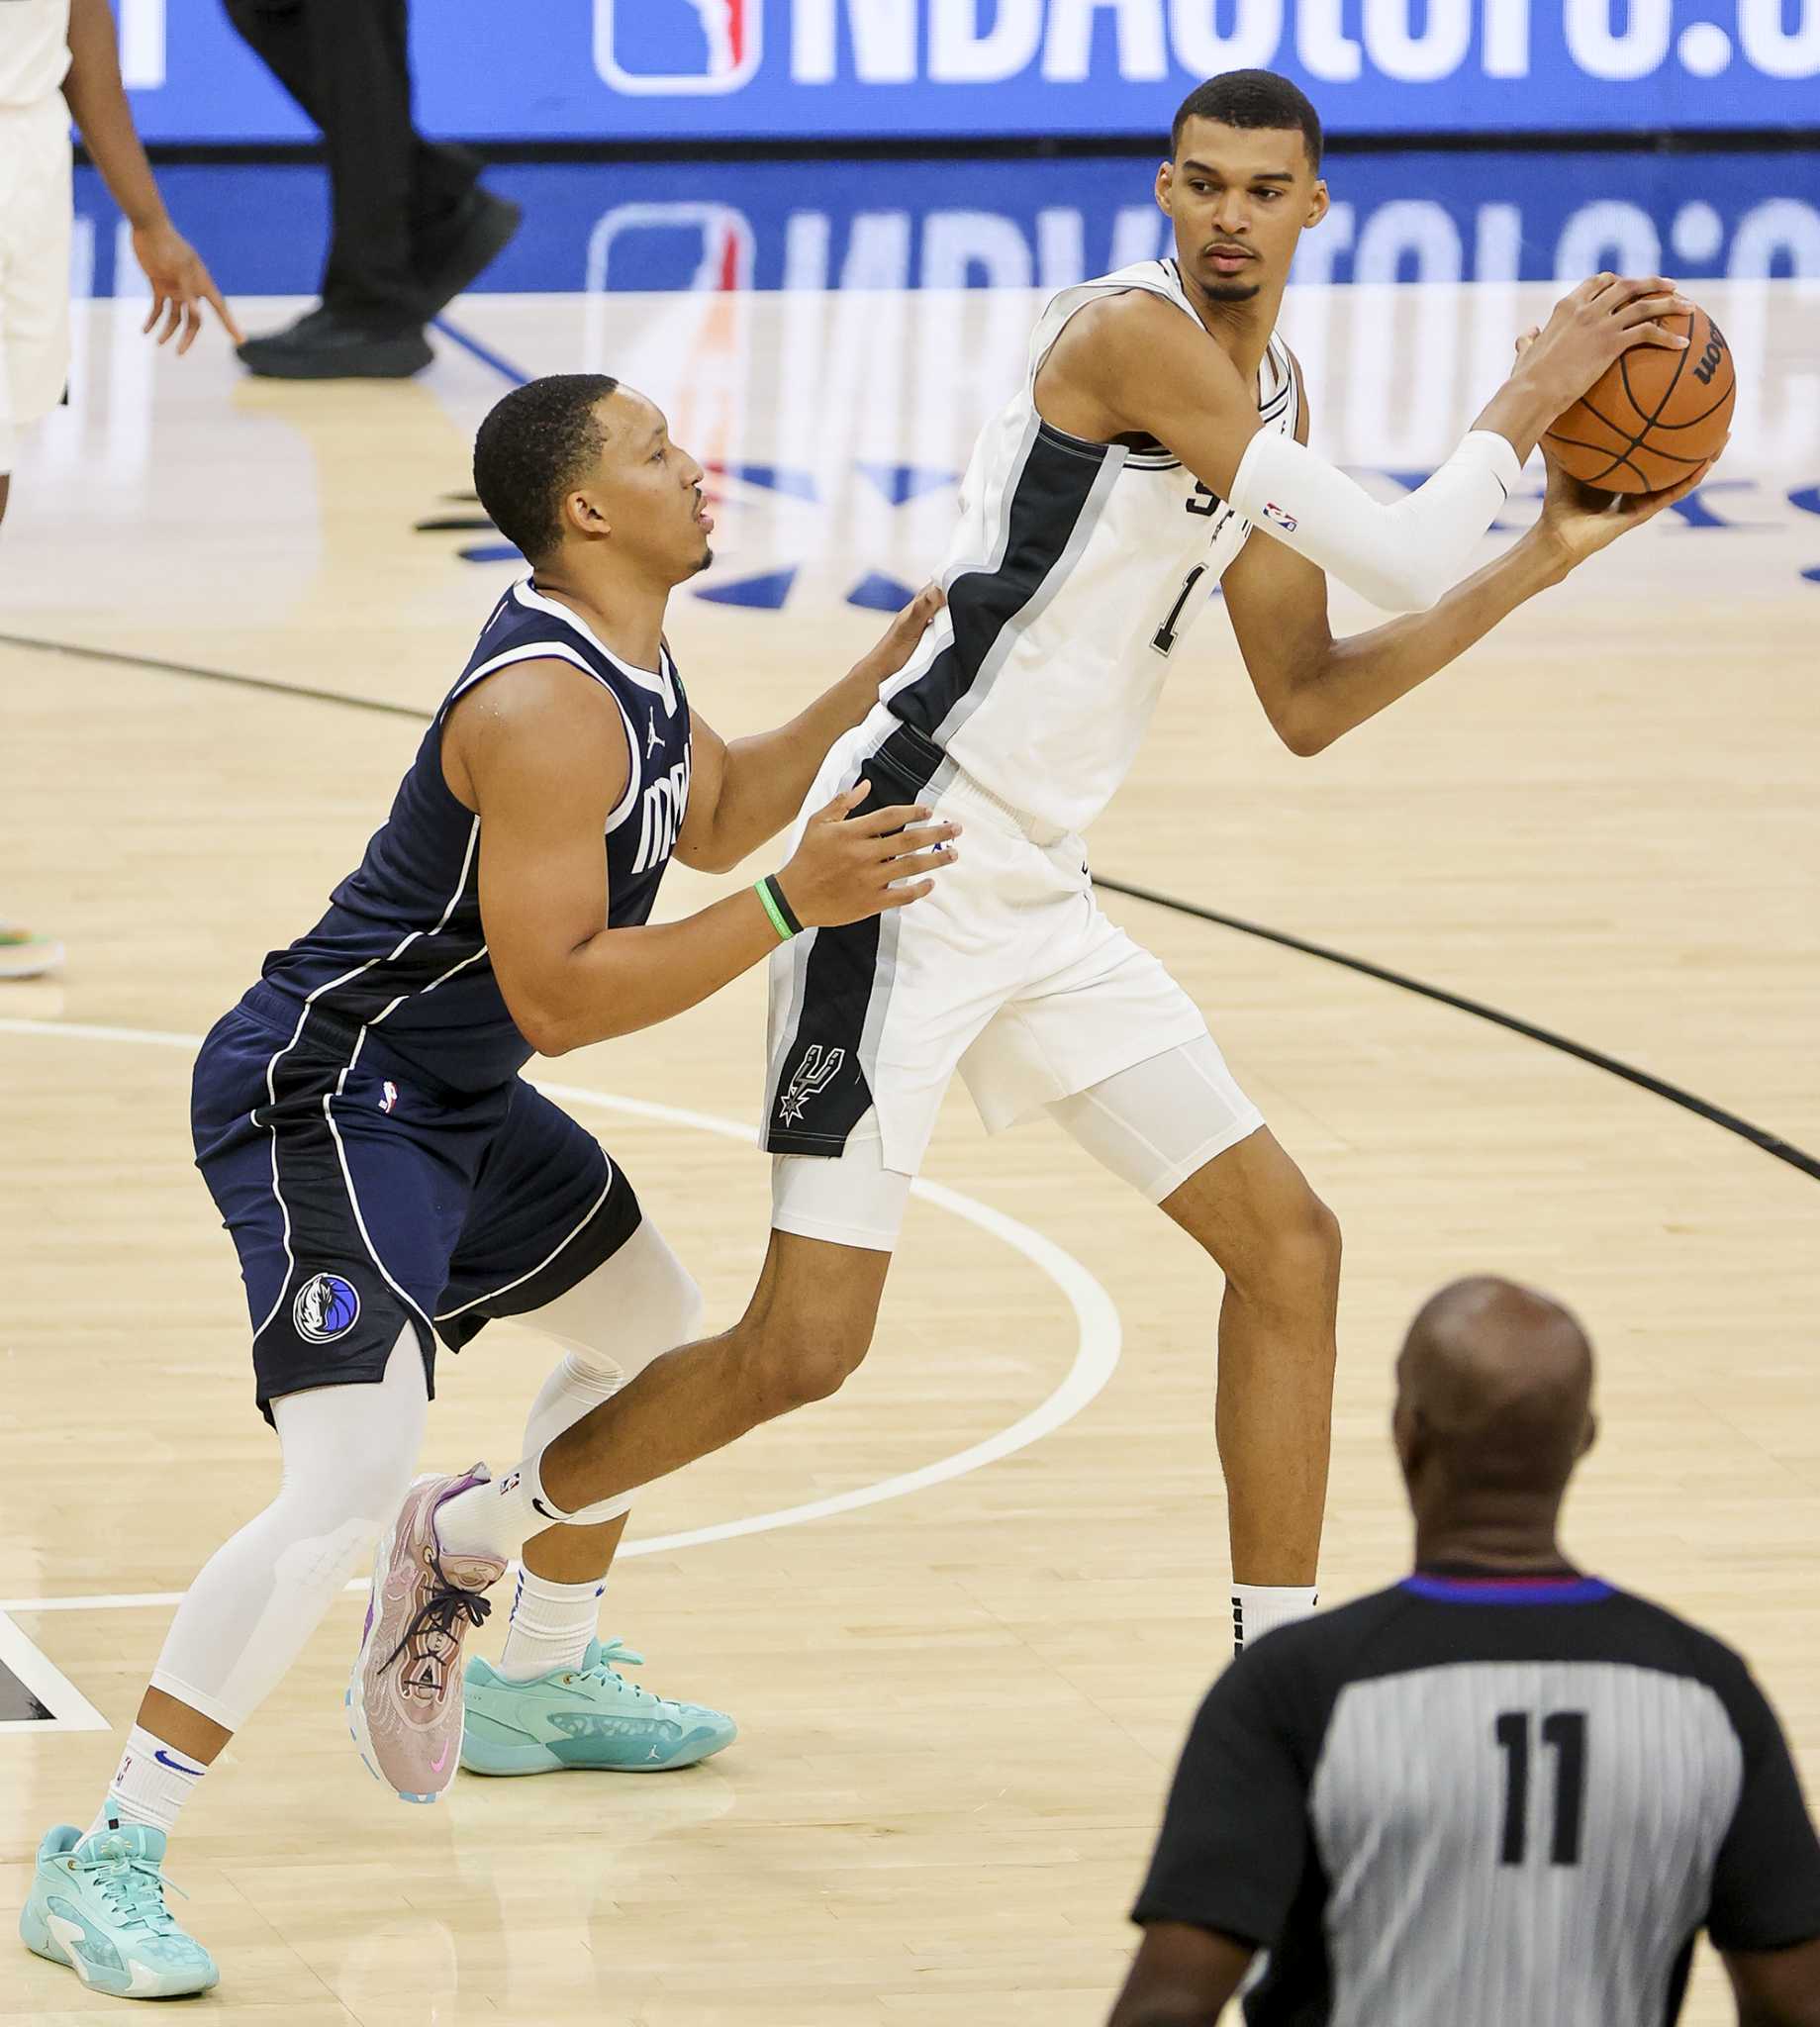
[358, 71, 1682, 1786]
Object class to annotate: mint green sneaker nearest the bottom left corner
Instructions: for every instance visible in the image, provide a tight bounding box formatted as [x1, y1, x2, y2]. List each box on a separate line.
[18, 1822, 221, 1998]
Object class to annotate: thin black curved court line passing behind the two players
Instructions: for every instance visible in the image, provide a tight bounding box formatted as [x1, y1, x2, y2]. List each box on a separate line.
[0, 632, 1820, 1182]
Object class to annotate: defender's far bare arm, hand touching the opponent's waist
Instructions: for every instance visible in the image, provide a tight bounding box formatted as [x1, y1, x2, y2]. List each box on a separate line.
[677, 584, 942, 874]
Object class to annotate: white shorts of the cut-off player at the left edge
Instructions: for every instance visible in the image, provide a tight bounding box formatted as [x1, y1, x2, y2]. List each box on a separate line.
[0, 91, 73, 472]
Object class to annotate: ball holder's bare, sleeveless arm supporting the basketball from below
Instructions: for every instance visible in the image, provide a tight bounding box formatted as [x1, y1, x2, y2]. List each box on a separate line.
[1220, 352, 1708, 754]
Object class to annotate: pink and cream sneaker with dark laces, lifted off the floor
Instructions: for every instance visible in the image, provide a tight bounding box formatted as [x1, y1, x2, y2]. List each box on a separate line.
[346, 1464, 507, 1802]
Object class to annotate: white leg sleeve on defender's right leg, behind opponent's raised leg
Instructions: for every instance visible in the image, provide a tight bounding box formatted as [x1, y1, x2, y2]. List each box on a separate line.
[513, 1218, 702, 1526]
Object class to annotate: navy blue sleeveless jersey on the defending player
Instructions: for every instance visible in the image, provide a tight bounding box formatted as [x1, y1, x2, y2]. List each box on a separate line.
[253, 580, 689, 1091]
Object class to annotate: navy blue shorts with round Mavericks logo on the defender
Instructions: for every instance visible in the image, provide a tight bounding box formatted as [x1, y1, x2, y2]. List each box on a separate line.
[191, 985, 640, 1421]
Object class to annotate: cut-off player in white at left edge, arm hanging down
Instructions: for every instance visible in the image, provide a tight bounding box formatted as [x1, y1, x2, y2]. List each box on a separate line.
[0, 0, 241, 979]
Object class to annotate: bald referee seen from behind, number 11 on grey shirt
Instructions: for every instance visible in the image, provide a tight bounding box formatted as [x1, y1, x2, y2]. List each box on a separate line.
[1110, 1279, 1820, 2027]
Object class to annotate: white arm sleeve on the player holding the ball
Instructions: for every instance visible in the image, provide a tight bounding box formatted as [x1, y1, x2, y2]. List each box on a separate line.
[1232, 430, 1522, 612]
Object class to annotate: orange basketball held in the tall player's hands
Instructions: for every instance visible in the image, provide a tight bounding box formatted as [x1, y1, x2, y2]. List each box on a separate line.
[1544, 308, 1737, 493]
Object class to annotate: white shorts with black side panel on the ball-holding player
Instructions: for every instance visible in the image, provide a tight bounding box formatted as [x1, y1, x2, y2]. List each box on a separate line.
[764, 710, 1263, 1251]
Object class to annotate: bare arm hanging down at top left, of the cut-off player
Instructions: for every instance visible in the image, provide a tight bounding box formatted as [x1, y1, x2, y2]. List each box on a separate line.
[62, 0, 245, 352]
